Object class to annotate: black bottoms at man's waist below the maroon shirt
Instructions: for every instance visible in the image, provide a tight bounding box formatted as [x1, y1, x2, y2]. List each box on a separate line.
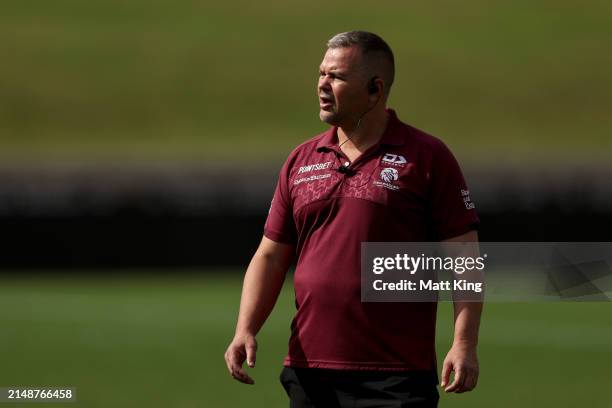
[280, 367, 439, 408]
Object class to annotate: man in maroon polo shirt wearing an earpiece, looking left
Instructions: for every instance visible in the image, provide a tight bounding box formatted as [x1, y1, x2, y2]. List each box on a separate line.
[225, 31, 482, 407]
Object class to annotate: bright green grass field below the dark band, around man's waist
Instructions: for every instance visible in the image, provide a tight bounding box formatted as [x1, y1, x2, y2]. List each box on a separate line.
[0, 271, 612, 408]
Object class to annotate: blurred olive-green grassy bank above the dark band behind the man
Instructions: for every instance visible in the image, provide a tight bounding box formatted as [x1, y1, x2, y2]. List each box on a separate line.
[0, 0, 612, 165]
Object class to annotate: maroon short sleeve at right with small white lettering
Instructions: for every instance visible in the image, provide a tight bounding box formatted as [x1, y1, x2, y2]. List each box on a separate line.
[429, 142, 480, 241]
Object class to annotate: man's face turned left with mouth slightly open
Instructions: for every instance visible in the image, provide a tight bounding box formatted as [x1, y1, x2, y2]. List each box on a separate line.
[317, 47, 369, 127]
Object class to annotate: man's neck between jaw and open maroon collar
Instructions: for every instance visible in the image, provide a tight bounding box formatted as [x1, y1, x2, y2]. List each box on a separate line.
[338, 109, 389, 153]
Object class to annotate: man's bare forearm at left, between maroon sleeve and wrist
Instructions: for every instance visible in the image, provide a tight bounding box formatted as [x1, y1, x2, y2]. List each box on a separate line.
[236, 237, 292, 336]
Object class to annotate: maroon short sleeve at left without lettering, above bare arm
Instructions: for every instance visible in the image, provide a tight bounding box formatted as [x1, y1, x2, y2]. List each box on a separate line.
[264, 162, 297, 245]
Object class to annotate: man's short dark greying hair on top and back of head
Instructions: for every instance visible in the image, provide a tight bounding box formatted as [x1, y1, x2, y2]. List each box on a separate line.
[327, 31, 395, 95]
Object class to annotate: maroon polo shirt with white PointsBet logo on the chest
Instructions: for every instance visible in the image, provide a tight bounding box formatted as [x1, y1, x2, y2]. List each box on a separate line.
[264, 110, 478, 370]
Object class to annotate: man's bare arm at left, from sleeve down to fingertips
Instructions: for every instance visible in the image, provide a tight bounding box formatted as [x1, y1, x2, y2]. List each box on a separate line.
[225, 237, 295, 384]
